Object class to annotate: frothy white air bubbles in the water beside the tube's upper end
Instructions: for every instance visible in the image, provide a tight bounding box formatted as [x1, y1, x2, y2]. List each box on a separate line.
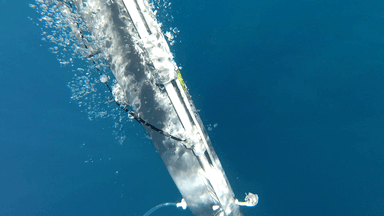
[30, 0, 179, 144]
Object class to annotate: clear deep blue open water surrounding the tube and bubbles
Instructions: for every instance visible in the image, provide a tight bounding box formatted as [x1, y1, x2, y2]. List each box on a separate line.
[0, 0, 384, 216]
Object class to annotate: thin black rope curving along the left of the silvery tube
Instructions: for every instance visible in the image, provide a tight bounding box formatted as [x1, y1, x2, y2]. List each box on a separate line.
[66, 2, 186, 142]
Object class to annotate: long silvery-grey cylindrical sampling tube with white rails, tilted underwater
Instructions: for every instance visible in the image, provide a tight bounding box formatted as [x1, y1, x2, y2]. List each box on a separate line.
[32, 0, 258, 216]
